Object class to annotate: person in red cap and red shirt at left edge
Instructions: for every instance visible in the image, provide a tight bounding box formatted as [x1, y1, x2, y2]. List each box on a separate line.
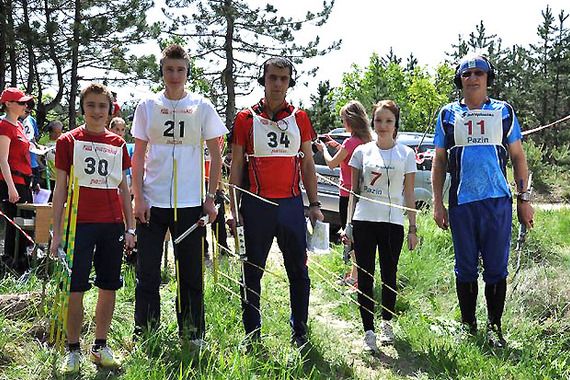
[0, 87, 33, 273]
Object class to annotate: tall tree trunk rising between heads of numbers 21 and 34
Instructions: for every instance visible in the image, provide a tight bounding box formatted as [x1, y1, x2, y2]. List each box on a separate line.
[222, 0, 236, 130]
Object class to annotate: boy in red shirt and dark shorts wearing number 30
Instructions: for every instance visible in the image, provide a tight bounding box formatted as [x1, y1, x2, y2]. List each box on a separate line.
[51, 83, 135, 374]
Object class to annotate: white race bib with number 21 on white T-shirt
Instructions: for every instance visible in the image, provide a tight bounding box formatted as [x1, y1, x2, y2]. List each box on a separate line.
[149, 104, 202, 145]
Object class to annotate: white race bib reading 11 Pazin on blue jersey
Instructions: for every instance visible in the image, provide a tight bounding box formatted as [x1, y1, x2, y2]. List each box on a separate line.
[453, 110, 503, 146]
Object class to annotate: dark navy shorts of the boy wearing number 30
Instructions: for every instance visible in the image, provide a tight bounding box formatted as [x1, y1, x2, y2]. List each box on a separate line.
[71, 223, 125, 292]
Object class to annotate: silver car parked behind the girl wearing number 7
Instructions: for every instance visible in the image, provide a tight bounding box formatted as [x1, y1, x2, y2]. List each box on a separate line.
[303, 128, 450, 232]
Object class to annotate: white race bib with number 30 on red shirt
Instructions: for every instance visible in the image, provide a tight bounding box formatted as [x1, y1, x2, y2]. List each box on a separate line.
[73, 140, 123, 189]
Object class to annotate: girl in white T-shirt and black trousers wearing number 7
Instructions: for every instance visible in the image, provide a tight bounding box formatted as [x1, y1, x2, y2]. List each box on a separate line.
[349, 100, 418, 352]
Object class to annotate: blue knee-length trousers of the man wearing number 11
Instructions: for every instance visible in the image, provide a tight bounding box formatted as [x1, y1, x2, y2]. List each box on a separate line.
[449, 197, 513, 285]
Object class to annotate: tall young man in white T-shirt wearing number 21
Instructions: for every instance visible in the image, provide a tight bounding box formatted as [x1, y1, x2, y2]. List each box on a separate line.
[132, 45, 227, 347]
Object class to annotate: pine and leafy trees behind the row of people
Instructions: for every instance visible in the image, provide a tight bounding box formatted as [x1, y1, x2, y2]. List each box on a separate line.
[0, 0, 570, 196]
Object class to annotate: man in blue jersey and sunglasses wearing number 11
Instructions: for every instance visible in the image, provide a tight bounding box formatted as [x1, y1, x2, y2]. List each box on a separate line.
[432, 56, 534, 347]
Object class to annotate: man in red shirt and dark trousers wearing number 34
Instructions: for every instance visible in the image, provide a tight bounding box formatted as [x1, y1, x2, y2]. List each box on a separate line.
[230, 57, 324, 348]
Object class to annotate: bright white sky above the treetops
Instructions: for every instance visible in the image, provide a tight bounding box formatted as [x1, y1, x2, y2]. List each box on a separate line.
[119, 0, 570, 107]
